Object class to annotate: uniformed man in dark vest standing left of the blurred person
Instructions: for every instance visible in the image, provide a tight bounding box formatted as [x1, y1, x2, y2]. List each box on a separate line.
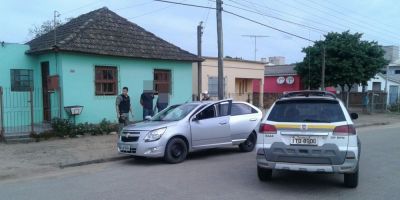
[115, 87, 133, 130]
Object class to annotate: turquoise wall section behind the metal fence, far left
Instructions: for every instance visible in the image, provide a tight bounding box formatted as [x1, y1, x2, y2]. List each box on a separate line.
[0, 43, 61, 132]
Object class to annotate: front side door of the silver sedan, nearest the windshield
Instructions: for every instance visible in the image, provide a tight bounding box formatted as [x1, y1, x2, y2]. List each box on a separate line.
[190, 101, 232, 148]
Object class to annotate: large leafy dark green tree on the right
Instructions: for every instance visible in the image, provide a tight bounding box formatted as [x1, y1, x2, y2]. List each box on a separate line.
[295, 31, 389, 91]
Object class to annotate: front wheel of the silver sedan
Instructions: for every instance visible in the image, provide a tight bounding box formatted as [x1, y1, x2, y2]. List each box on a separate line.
[164, 138, 188, 164]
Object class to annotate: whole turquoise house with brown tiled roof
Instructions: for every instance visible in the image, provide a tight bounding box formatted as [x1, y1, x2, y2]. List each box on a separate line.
[0, 7, 200, 134]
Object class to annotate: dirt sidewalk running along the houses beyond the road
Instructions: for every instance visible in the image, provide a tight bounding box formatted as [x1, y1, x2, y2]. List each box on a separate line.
[0, 114, 400, 181]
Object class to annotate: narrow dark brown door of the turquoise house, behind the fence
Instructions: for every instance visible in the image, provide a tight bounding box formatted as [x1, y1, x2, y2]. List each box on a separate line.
[41, 62, 51, 121]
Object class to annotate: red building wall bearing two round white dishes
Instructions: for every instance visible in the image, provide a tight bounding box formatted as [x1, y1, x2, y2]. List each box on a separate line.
[264, 75, 301, 93]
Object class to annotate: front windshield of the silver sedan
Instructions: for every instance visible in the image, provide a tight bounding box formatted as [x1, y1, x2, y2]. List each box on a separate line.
[151, 104, 198, 121]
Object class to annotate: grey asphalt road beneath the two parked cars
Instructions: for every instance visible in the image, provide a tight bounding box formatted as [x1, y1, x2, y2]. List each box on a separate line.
[0, 124, 400, 200]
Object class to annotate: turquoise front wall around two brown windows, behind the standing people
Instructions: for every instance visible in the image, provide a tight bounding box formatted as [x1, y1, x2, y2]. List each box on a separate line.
[61, 53, 192, 123]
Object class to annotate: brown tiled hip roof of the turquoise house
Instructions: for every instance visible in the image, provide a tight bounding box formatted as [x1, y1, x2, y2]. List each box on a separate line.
[27, 7, 201, 61]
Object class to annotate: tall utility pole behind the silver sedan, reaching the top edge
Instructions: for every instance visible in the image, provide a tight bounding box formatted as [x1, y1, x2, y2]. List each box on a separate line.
[216, 0, 224, 100]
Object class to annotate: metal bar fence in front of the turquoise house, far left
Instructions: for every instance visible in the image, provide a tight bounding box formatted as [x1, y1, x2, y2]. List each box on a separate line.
[0, 87, 60, 136]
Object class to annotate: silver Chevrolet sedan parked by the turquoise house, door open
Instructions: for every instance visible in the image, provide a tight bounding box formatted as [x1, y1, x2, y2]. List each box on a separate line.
[118, 100, 262, 163]
